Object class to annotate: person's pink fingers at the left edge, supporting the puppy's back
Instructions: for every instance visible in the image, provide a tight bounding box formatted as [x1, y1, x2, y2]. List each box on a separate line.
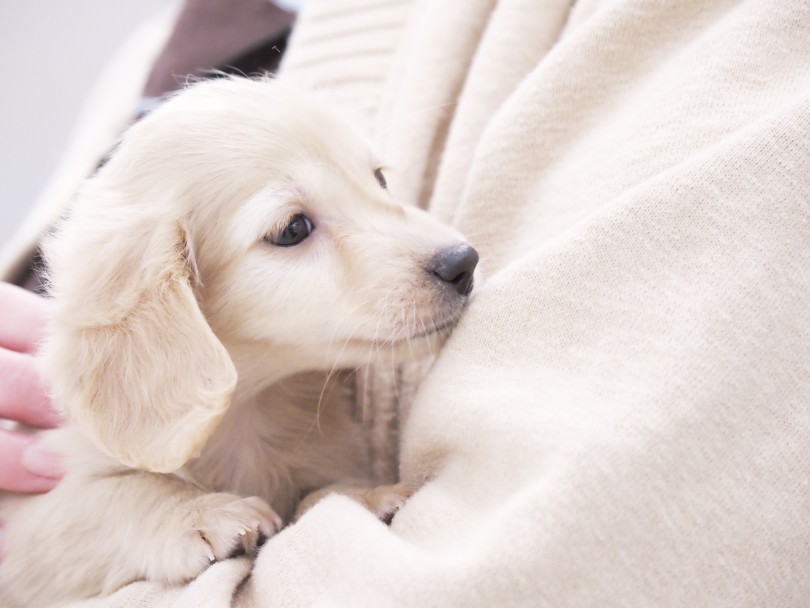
[0, 282, 62, 492]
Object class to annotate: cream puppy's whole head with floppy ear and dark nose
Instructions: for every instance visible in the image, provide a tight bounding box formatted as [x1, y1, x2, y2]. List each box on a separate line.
[43, 79, 478, 471]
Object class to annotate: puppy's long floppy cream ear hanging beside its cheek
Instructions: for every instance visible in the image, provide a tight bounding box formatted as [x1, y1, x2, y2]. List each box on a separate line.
[42, 182, 236, 472]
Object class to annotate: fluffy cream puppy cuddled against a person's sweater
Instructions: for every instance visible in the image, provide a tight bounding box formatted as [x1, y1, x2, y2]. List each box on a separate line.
[0, 79, 478, 606]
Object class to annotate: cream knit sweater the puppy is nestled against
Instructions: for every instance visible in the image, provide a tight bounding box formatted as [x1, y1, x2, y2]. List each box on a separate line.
[22, 0, 810, 608]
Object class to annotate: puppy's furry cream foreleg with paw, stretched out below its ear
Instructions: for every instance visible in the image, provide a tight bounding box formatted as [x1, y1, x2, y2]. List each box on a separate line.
[0, 469, 281, 606]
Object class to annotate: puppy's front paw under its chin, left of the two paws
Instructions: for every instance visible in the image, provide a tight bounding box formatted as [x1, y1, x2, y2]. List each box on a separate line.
[159, 493, 282, 583]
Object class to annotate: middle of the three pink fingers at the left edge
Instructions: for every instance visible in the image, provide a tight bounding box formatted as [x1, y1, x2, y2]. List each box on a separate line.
[0, 348, 61, 428]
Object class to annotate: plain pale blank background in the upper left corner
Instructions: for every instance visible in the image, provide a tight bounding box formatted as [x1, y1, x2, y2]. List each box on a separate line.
[0, 0, 170, 244]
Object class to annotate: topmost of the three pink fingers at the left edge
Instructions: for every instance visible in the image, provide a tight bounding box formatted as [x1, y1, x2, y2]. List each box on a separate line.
[0, 282, 50, 353]
